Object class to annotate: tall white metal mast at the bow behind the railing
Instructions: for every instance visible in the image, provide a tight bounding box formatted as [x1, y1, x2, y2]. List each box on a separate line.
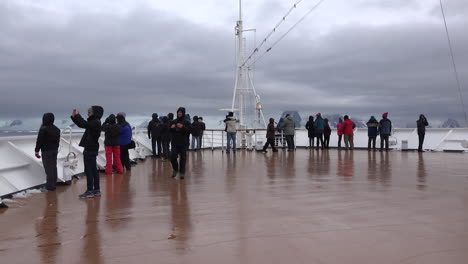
[231, 0, 266, 128]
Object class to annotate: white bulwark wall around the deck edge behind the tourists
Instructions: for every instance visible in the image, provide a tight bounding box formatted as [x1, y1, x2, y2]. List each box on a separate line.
[0, 128, 468, 197]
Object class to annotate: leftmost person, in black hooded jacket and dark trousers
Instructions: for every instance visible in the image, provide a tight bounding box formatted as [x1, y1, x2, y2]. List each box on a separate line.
[35, 113, 60, 191]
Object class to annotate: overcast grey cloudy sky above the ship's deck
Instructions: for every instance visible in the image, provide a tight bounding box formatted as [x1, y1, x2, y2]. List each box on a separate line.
[0, 0, 468, 125]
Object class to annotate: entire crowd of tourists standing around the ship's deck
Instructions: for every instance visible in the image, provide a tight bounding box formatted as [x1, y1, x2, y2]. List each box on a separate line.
[35, 109, 429, 198]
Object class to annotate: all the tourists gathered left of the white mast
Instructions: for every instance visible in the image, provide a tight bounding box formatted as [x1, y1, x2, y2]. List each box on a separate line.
[35, 106, 201, 198]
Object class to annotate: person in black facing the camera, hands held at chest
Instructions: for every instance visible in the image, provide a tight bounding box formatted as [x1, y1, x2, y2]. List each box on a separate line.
[170, 107, 190, 179]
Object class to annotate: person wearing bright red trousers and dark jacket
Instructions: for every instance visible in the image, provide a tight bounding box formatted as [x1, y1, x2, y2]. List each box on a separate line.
[101, 114, 123, 174]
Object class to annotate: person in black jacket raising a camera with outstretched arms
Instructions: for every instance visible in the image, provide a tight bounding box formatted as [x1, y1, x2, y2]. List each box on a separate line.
[71, 106, 104, 198]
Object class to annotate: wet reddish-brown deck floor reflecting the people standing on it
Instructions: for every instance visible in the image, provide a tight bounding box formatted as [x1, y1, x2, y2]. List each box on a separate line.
[0, 150, 468, 264]
